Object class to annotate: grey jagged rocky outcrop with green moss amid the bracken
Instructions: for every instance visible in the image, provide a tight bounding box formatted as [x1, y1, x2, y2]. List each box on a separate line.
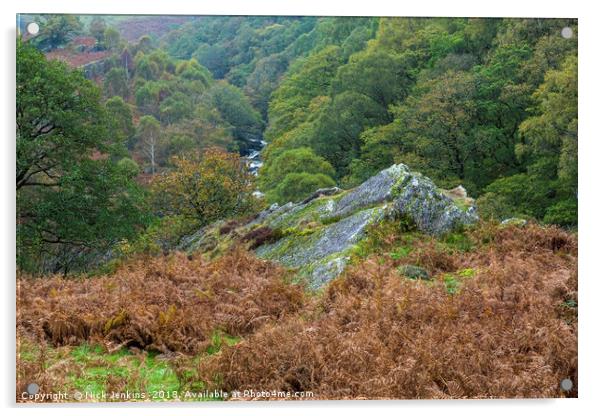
[180, 164, 478, 288]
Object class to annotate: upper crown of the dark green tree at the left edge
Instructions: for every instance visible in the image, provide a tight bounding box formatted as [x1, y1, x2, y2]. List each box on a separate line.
[16, 41, 107, 190]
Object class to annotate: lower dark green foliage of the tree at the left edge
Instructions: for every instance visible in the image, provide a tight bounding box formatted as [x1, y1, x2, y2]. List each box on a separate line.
[17, 160, 146, 274]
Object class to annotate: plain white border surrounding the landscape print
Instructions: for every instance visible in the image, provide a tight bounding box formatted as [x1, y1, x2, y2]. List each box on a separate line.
[0, 0, 602, 416]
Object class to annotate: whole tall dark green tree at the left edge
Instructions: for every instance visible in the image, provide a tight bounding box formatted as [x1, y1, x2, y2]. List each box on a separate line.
[16, 41, 146, 274]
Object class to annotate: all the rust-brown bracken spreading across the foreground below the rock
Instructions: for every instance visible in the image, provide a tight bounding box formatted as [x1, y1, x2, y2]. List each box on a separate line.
[17, 225, 578, 399]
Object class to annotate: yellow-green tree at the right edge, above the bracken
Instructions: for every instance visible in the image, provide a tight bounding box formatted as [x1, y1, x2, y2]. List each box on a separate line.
[500, 55, 578, 226]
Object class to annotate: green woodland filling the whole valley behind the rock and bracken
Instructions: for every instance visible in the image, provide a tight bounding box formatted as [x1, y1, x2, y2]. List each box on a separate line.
[17, 15, 577, 272]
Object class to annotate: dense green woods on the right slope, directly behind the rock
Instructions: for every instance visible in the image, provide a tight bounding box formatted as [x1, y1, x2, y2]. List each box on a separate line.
[260, 19, 577, 225]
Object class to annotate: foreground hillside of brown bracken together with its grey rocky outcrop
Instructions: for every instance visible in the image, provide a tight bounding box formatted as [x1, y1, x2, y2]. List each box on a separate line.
[17, 166, 577, 399]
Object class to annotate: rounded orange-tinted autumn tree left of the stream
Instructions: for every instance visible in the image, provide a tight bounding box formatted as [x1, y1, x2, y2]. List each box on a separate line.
[152, 148, 255, 226]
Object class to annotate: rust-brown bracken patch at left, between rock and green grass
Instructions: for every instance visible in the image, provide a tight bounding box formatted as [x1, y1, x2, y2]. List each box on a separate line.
[17, 251, 304, 354]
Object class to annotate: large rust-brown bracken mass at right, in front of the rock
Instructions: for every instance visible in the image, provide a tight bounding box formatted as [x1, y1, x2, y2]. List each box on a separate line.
[199, 225, 578, 400]
